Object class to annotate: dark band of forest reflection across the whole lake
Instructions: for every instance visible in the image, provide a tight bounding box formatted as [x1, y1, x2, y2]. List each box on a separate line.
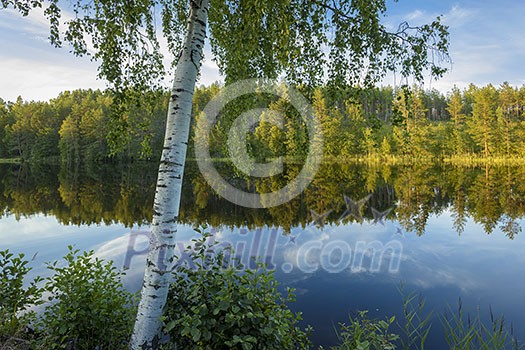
[0, 162, 525, 239]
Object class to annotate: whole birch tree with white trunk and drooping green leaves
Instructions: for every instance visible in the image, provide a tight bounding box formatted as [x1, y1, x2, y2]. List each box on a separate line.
[1, 0, 448, 349]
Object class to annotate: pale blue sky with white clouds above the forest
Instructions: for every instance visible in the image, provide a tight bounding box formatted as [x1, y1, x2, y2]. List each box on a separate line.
[0, 0, 525, 101]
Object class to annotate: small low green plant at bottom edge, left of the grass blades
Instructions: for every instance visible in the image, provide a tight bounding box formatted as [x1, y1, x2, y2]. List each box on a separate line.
[324, 311, 399, 350]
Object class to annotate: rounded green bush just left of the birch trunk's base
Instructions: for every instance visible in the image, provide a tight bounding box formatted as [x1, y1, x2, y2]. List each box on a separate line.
[38, 246, 136, 350]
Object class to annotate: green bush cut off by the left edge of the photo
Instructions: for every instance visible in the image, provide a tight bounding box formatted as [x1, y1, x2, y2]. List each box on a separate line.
[0, 249, 43, 345]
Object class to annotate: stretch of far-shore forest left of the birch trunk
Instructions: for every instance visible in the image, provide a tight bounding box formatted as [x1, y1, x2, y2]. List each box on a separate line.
[0, 89, 167, 164]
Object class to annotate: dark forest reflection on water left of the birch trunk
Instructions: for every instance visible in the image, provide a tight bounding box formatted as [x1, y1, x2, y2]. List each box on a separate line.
[0, 163, 156, 227]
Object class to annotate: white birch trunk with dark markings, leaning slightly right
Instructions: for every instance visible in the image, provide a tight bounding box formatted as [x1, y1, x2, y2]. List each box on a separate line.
[130, 0, 209, 350]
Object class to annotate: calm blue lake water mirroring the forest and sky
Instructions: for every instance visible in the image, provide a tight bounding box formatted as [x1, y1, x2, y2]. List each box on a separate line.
[0, 163, 525, 349]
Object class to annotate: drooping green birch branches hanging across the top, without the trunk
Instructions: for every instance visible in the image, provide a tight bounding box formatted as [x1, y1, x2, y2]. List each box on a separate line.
[1, 0, 449, 91]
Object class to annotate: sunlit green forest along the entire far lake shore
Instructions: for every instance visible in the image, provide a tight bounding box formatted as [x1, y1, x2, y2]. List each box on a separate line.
[0, 83, 525, 164]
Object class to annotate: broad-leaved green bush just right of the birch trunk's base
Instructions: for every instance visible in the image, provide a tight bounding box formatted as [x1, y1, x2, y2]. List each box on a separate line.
[164, 231, 309, 350]
